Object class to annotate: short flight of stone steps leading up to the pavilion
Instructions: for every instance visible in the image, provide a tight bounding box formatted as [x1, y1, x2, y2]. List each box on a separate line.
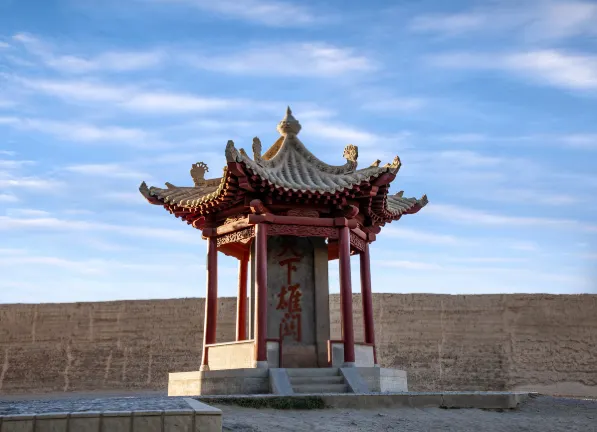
[286, 368, 350, 394]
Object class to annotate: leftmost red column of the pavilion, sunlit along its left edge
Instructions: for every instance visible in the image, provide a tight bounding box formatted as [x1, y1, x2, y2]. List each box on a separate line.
[201, 237, 218, 370]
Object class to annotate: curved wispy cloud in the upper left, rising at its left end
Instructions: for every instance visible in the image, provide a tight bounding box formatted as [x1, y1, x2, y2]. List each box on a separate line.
[13, 33, 165, 74]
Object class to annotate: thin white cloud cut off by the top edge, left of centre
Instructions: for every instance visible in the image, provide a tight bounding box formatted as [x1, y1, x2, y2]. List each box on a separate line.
[153, 0, 317, 27]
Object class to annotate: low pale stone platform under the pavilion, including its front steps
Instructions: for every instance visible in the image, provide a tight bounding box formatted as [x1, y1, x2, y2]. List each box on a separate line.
[168, 366, 408, 396]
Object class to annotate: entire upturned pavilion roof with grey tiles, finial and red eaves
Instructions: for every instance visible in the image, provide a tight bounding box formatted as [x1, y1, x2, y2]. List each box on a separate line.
[139, 108, 427, 228]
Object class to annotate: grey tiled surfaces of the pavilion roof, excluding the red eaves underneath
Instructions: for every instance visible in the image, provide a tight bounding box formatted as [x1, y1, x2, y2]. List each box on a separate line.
[139, 105, 427, 220]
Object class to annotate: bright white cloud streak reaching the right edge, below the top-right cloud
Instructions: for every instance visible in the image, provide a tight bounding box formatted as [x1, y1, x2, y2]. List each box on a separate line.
[430, 50, 597, 90]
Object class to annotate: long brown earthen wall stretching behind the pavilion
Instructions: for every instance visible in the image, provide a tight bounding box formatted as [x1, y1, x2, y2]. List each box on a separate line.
[0, 294, 597, 395]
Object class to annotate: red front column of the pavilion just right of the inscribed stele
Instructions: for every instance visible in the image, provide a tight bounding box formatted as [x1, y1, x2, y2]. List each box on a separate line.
[338, 226, 354, 366]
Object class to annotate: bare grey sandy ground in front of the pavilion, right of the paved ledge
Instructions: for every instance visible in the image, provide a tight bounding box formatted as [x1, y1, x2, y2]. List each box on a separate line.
[217, 396, 597, 432]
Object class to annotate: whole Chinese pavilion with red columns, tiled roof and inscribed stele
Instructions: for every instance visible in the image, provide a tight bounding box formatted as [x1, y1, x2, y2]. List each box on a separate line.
[139, 108, 427, 394]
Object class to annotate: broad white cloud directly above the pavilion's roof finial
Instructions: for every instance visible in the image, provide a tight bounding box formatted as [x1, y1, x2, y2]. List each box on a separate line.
[188, 43, 377, 77]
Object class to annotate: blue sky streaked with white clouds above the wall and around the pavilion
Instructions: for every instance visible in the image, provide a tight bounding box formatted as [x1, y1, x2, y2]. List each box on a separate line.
[0, 0, 597, 303]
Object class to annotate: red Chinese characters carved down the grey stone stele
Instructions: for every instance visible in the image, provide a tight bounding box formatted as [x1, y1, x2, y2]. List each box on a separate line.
[276, 242, 303, 342]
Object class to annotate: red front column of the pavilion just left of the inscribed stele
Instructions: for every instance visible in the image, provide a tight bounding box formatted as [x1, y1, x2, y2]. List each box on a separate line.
[255, 223, 267, 367]
